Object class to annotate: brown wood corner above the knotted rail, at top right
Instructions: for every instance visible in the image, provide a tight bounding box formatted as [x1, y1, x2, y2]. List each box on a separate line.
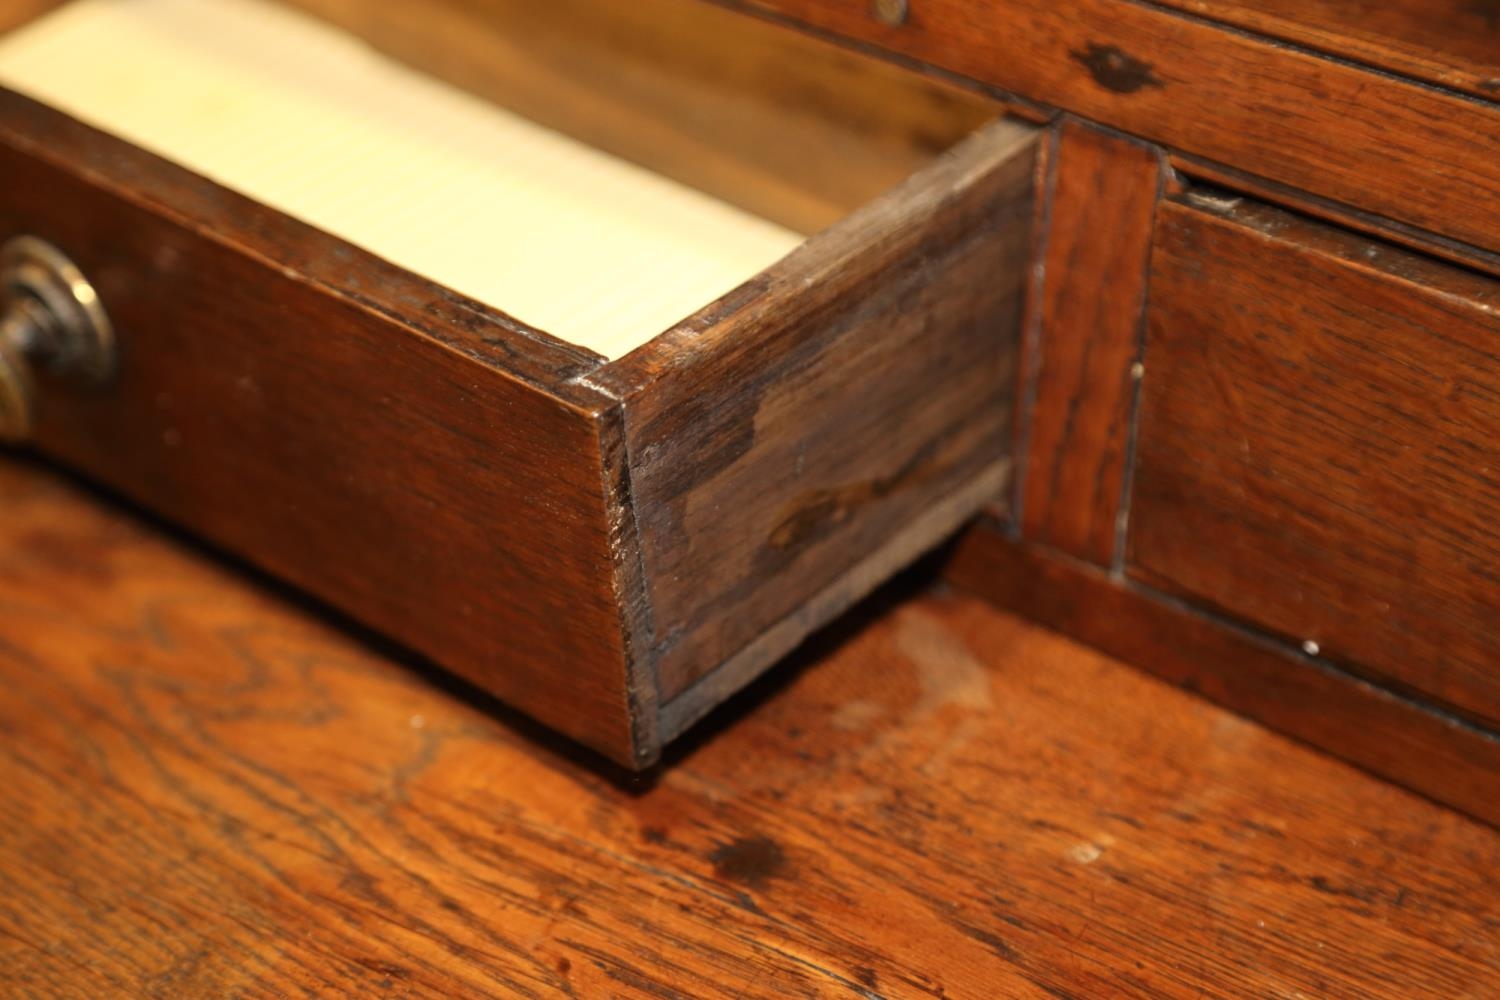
[1157, 0, 1500, 100]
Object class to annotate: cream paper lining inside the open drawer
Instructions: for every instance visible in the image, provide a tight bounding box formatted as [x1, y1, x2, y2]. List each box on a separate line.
[0, 0, 803, 358]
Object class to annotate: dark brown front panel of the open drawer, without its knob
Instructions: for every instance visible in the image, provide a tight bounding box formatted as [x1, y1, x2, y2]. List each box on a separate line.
[0, 93, 645, 757]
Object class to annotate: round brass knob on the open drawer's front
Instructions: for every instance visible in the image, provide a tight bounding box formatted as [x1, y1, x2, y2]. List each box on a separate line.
[0, 235, 114, 444]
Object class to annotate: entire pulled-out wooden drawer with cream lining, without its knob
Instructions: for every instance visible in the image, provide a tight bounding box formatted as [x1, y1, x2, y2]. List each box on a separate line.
[0, 0, 1035, 766]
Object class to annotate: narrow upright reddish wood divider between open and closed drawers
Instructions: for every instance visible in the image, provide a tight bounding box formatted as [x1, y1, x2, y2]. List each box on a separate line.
[1020, 120, 1167, 565]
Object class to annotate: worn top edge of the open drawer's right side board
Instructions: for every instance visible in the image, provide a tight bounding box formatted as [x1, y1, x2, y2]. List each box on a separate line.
[576, 117, 1040, 395]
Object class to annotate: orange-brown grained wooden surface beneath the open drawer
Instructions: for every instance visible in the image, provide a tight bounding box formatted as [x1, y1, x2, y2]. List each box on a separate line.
[0, 465, 1500, 1000]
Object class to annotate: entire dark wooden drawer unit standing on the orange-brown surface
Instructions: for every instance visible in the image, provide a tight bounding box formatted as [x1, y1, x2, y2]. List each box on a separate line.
[0, 0, 1500, 822]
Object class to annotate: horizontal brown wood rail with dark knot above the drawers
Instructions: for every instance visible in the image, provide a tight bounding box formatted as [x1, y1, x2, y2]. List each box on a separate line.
[744, 0, 1500, 257]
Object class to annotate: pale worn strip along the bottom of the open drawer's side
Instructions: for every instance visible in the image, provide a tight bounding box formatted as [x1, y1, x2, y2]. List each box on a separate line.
[660, 459, 1011, 741]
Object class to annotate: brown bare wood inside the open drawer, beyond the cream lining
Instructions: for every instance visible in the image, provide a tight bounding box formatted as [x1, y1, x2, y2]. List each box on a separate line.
[287, 0, 998, 232]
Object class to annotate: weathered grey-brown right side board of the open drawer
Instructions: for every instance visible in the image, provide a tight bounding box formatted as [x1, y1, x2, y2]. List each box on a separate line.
[587, 120, 1038, 703]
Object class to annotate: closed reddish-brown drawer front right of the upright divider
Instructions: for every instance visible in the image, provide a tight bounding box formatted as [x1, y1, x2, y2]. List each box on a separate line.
[1128, 196, 1500, 724]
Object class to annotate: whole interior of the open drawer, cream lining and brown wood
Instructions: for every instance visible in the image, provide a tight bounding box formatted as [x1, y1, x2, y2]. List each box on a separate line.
[0, 0, 1001, 358]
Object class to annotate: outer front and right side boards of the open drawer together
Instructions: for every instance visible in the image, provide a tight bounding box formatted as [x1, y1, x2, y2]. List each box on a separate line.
[0, 80, 1038, 766]
